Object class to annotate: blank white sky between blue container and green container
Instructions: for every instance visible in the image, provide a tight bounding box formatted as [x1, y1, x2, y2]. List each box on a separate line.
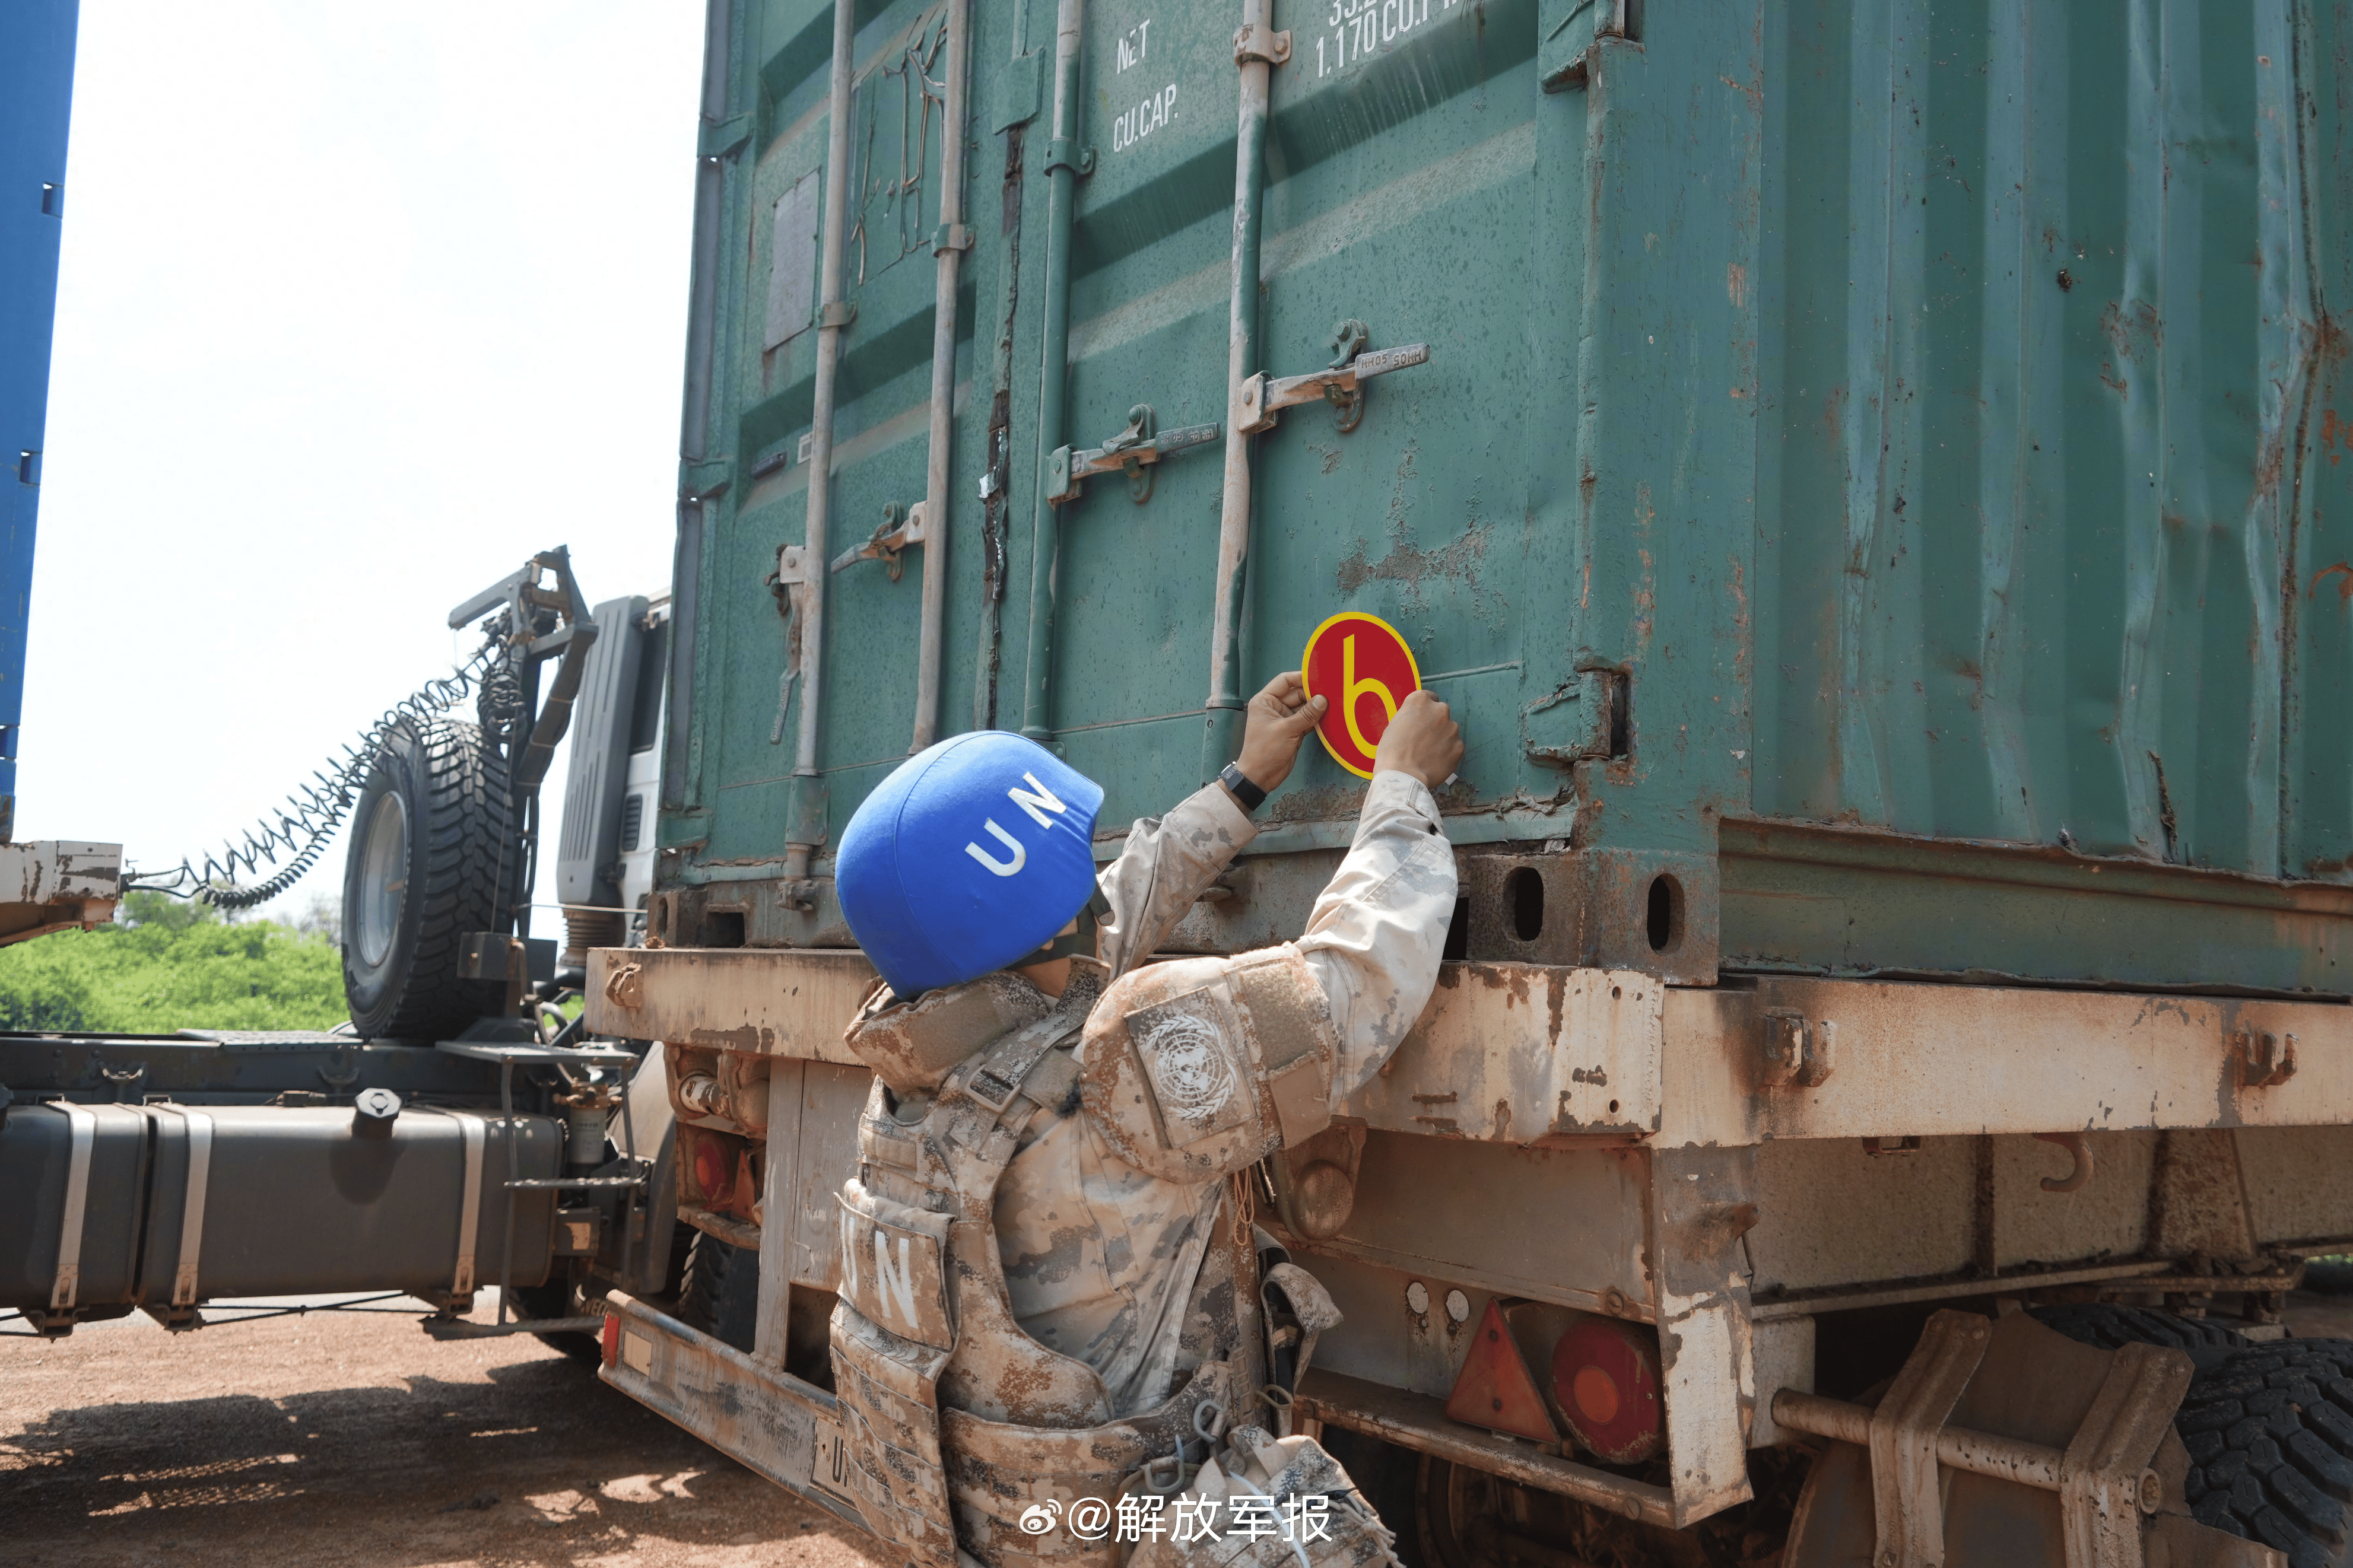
[32, 0, 704, 936]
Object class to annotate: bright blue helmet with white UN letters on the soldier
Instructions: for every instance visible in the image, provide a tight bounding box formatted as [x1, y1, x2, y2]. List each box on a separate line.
[833, 729, 1104, 997]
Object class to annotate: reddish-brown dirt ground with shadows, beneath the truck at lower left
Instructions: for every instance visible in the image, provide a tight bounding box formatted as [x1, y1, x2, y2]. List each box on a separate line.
[0, 1295, 873, 1568]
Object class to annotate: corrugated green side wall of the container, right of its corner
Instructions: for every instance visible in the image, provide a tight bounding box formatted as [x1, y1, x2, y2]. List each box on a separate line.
[1753, 0, 2353, 879]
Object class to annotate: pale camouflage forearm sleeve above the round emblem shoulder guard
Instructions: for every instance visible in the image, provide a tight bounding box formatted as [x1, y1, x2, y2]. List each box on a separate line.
[1299, 771, 1454, 1105]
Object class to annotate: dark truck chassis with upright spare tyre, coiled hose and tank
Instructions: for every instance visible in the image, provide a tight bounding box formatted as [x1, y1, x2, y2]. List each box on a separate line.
[0, 548, 699, 1354]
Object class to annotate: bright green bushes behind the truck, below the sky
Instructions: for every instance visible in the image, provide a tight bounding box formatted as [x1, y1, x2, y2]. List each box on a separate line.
[0, 893, 351, 1035]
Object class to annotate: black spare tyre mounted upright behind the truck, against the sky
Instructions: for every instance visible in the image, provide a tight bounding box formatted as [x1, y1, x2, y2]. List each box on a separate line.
[344, 720, 522, 1044]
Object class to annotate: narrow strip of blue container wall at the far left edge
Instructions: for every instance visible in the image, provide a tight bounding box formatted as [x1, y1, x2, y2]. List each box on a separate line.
[0, 0, 80, 844]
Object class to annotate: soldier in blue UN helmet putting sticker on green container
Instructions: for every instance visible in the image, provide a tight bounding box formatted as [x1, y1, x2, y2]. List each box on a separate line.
[833, 672, 1463, 1568]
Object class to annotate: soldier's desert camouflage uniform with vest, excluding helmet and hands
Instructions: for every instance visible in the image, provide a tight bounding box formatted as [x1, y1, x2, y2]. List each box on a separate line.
[833, 771, 1454, 1568]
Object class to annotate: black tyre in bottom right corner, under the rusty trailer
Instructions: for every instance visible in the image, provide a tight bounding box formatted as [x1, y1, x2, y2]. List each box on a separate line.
[2174, 1340, 2353, 1568]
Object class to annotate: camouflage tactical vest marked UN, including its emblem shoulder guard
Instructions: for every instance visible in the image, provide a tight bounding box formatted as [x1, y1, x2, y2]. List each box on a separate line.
[833, 947, 1339, 1568]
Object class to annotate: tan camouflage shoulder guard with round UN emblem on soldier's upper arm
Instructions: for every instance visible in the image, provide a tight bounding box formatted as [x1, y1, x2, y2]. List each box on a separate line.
[1082, 945, 1339, 1182]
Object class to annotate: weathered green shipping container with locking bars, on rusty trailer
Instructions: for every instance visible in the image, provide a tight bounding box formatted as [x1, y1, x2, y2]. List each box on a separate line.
[654, 0, 2353, 994]
